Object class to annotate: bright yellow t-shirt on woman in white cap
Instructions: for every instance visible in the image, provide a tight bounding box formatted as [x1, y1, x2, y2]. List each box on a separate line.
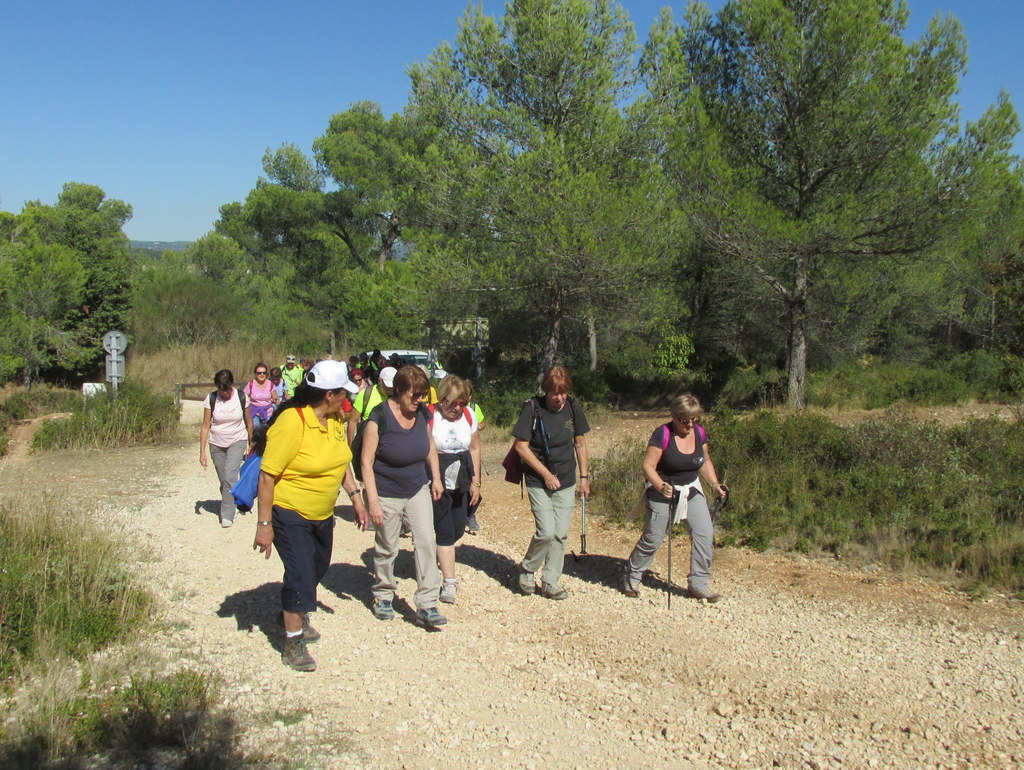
[260, 407, 352, 521]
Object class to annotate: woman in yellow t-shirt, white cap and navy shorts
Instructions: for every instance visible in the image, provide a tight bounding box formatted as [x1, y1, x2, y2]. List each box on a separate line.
[253, 360, 369, 671]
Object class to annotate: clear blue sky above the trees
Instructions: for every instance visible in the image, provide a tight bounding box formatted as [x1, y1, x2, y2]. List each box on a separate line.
[0, 0, 1024, 241]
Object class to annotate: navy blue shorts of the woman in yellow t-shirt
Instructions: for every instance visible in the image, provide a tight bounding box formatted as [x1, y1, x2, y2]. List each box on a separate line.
[272, 506, 334, 612]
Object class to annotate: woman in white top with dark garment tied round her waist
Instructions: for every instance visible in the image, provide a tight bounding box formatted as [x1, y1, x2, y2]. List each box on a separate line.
[431, 375, 480, 604]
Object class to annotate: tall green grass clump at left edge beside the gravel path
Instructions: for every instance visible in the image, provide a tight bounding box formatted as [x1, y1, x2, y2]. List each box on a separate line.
[0, 500, 150, 679]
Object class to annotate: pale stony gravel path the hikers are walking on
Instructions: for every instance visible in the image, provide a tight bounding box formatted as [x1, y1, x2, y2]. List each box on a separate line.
[3, 409, 1024, 768]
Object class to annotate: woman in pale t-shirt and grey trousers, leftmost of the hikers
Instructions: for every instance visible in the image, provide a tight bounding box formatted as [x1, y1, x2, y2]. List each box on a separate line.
[199, 367, 253, 527]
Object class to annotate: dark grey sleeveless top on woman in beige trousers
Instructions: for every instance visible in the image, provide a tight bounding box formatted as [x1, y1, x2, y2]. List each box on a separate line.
[367, 400, 430, 500]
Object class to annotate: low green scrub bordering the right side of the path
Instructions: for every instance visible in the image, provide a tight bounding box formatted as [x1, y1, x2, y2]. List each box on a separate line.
[593, 412, 1024, 592]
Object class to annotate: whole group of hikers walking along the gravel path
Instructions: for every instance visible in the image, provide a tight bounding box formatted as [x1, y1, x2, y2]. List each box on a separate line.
[200, 350, 728, 672]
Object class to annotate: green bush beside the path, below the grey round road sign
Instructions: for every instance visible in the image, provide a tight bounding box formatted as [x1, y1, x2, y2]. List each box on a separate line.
[32, 381, 178, 450]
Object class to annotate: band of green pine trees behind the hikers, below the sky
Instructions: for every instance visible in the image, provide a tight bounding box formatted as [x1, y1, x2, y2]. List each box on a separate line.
[0, 0, 1024, 405]
